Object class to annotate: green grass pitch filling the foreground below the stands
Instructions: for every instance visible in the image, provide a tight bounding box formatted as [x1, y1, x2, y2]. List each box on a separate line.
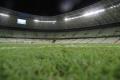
[0, 43, 120, 80]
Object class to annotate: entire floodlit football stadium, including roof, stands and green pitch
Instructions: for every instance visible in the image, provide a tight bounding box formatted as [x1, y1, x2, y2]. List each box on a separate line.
[0, 0, 120, 80]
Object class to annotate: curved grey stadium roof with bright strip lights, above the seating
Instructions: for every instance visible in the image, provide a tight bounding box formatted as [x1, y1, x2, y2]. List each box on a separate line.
[0, 0, 120, 30]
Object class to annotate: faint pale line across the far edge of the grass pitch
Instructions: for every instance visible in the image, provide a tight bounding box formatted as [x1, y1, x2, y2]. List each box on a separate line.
[0, 45, 120, 50]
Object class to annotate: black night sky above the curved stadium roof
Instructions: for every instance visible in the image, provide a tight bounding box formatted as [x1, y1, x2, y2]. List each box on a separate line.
[0, 0, 100, 16]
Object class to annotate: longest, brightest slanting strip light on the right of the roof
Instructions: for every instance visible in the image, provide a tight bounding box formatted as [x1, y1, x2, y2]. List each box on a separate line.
[64, 9, 105, 22]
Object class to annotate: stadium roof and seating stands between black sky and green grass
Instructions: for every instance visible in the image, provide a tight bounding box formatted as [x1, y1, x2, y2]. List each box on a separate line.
[0, 0, 120, 43]
